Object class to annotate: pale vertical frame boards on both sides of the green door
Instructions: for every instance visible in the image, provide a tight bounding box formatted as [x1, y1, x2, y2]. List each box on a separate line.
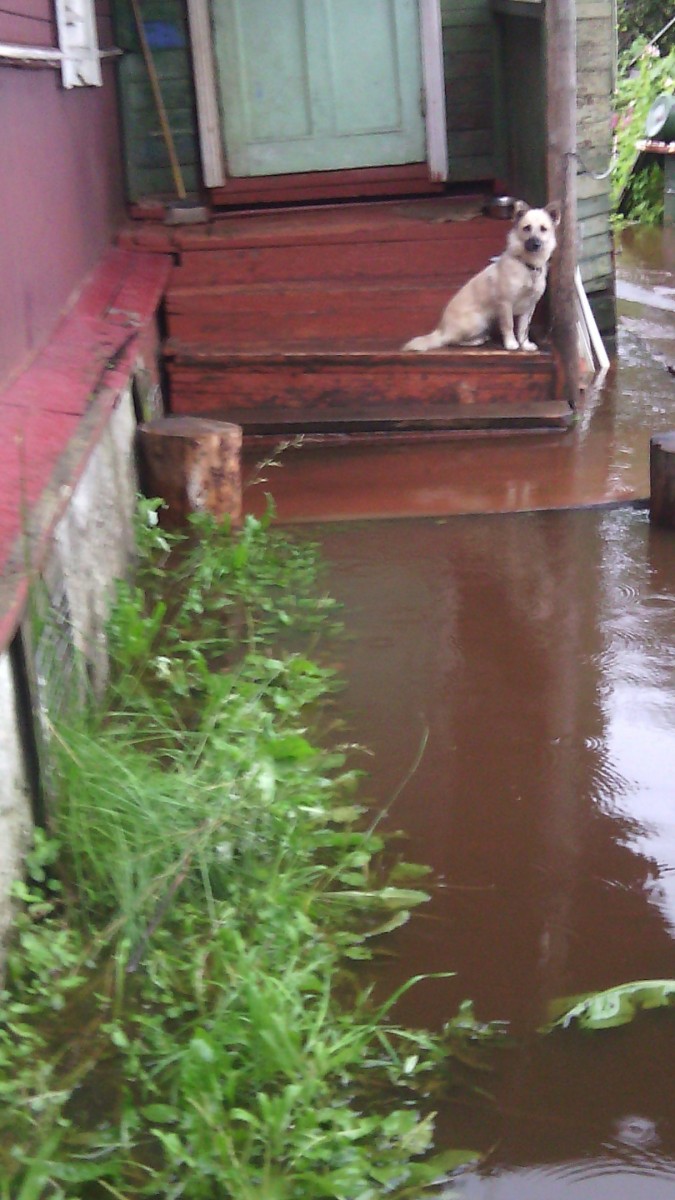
[187, 0, 448, 188]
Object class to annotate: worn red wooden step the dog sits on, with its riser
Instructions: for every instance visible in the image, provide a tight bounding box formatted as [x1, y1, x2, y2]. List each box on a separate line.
[166, 342, 560, 428]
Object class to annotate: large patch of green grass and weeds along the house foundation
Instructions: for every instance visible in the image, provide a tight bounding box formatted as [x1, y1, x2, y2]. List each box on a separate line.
[0, 505, 498, 1200]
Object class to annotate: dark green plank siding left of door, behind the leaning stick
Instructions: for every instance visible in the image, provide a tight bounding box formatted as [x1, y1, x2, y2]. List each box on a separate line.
[114, 0, 199, 200]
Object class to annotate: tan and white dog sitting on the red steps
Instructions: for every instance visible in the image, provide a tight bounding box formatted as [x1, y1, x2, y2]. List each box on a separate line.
[404, 200, 561, 352]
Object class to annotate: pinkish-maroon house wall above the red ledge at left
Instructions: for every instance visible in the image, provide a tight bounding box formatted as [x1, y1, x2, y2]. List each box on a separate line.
[0, 0, 124, 386]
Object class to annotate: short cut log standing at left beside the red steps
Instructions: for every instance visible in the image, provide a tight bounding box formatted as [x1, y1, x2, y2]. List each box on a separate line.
[138, 416, 241, 526]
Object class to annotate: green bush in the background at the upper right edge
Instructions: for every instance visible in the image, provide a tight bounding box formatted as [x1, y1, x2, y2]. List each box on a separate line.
[611, 44, 675, 224]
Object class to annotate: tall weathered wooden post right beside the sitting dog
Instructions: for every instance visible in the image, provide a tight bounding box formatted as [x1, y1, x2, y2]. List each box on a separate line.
[544, 0, 579, 408]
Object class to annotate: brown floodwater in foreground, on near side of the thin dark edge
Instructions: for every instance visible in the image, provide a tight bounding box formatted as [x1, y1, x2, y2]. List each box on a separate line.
[312, 510, 675, 1200]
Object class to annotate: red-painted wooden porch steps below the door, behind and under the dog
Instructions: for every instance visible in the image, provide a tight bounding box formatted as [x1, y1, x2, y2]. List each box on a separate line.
[123, 197, 572, 439]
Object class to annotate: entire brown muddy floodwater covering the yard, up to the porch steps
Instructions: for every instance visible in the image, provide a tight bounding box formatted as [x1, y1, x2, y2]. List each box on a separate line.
[242, 230, 675, 1200]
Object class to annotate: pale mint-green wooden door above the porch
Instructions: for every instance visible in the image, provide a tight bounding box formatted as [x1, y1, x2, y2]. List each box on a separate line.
[214, 0, 425, 176]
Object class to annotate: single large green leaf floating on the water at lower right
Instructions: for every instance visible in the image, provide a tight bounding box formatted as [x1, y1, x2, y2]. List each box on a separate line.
[542, 979, 675, 1033]
